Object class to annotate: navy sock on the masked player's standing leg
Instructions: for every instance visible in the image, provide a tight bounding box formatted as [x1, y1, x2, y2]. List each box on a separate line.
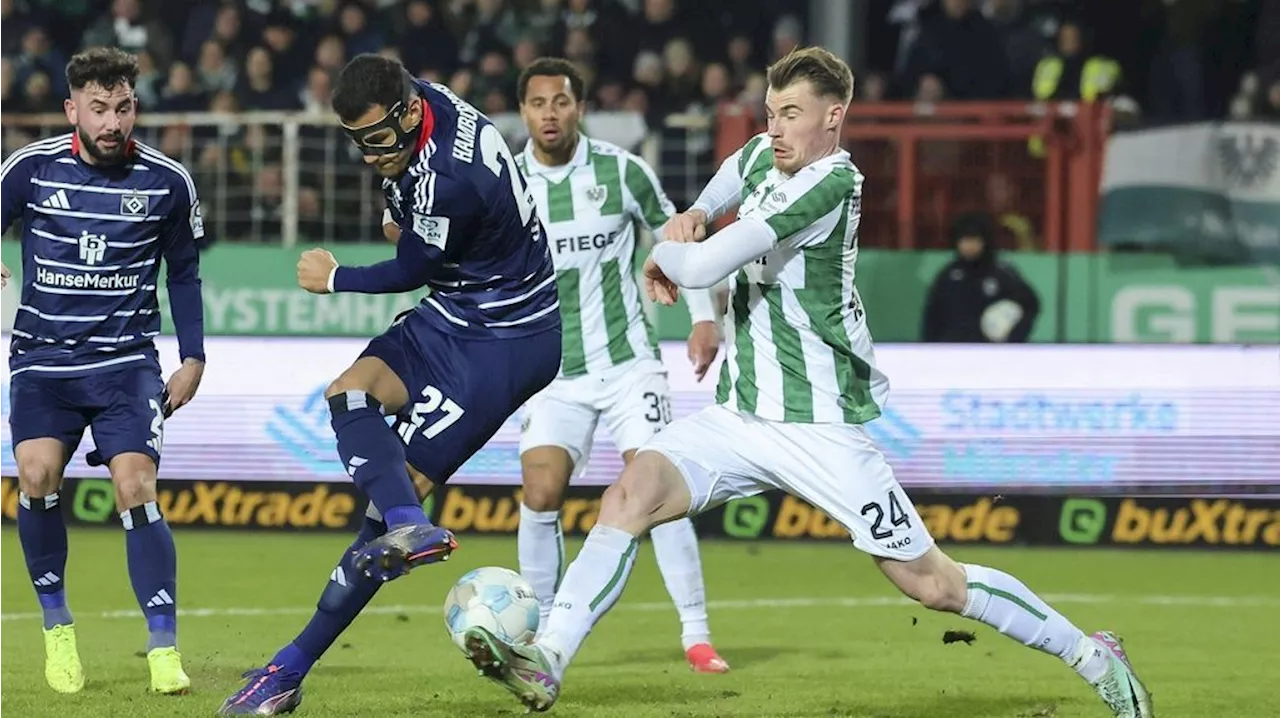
[271, 517, 387, 674]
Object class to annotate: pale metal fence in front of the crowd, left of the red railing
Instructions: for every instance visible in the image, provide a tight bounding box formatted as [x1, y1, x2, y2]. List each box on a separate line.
[0, 113, 714, 246]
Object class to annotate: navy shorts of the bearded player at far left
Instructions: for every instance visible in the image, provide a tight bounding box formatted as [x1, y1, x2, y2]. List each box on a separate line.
[9, 363, 164, 466]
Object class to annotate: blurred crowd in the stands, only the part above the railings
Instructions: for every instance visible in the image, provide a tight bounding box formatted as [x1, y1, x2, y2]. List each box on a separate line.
[0, 0, 1259, 122]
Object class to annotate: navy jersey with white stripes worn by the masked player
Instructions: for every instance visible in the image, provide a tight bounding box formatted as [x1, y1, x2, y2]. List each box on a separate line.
[333, 82, 559, 338]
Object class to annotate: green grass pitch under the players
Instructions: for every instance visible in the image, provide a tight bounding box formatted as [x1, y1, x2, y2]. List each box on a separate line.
[0, 525, 1280, 718]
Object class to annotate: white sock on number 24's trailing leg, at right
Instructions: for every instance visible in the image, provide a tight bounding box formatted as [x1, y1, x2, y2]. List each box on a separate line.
[960, 563, 1085, 668]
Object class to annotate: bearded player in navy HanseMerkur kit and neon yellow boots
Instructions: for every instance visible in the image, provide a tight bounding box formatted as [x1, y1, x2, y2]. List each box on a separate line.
[0, 49, 205, 694]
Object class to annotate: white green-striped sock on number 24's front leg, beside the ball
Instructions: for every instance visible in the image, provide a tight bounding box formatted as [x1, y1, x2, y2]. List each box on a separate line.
[538, 523, 637, 673]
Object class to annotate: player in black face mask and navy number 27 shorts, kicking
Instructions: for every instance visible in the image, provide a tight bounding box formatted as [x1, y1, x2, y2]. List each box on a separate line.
[221, 55, 561, 715]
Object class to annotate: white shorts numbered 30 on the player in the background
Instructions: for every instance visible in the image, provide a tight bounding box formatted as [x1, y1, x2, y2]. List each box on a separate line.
[520, 358, 671, 472]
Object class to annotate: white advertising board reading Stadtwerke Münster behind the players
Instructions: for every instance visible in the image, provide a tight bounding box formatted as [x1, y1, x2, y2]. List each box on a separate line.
[0, 337, 1280, 495]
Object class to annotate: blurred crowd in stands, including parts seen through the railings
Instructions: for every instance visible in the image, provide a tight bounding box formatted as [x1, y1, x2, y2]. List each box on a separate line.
[0, 0, 1280, 250]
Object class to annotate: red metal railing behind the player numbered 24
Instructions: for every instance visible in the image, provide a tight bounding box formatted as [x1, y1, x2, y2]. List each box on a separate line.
[713, 101, 1110, 252]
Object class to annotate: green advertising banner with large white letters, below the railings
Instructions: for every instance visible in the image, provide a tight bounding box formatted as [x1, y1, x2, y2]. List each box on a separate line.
[0, 242, 1280, 344]
